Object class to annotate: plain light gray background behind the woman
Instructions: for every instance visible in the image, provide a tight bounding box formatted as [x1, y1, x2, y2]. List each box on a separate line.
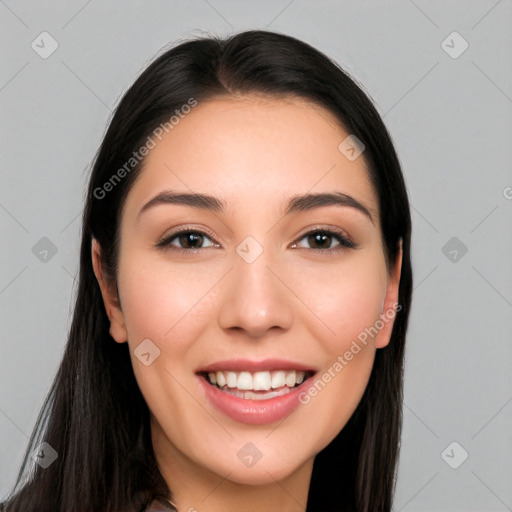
[0, 0, 512, 512]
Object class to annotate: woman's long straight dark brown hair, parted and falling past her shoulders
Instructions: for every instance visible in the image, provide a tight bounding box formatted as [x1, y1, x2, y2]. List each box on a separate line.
[0, 31, 412, 512]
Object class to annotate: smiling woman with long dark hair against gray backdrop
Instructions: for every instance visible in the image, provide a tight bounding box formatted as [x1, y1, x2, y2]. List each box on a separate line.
[2, 31, 412, 512]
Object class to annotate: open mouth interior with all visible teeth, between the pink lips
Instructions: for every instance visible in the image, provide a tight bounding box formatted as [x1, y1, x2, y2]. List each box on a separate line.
[198, 369, 315, 400]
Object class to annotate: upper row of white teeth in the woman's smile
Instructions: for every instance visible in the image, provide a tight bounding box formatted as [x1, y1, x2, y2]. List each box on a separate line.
[208, 370, 306, 392]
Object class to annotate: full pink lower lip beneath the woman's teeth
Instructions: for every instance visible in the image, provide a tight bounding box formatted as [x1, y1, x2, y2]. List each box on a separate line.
[198, 376, 312, 425]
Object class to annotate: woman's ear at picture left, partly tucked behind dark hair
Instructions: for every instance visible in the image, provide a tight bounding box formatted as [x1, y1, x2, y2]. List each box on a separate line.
[91, 238, 128, 343]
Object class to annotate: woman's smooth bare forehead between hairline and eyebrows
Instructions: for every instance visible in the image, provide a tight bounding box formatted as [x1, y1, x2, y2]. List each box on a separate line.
[122, 95, 378, 223]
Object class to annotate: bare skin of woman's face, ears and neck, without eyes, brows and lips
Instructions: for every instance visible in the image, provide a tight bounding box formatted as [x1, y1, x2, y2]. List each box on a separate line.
[92, 95, 401, 512]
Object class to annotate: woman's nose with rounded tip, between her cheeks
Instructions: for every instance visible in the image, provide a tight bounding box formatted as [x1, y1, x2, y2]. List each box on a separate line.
[218, 252, 294, 338]
